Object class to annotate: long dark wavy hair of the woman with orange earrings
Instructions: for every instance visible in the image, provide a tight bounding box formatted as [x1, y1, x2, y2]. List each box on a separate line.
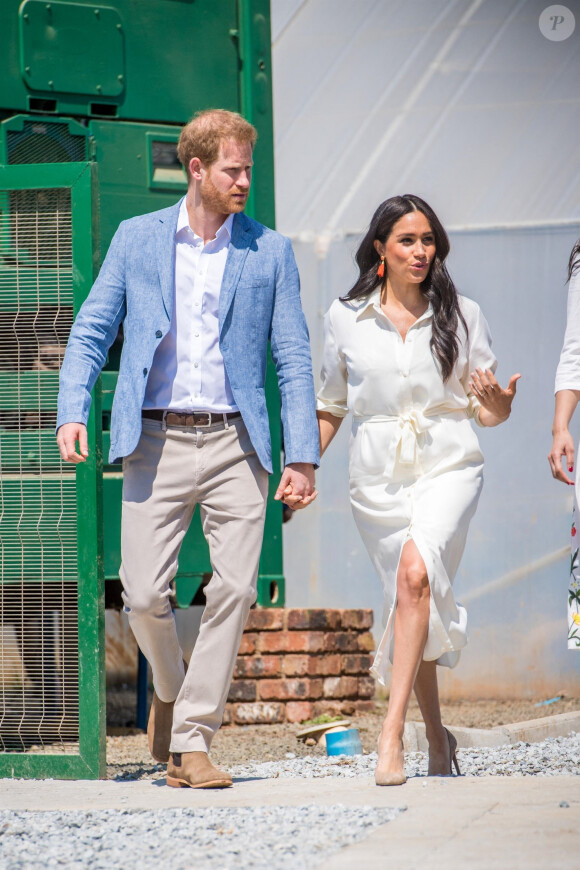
[341, 193, 468, 381]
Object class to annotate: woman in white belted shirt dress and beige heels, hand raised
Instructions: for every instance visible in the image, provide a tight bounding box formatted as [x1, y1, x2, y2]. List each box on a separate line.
[302, 195, 519, 785]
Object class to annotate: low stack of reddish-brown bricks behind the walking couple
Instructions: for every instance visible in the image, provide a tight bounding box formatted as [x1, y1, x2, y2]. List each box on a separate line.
[224, 608, 375, 725]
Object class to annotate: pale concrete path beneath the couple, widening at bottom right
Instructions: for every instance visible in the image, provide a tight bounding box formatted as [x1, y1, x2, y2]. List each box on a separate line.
[0, 776, 580, 870]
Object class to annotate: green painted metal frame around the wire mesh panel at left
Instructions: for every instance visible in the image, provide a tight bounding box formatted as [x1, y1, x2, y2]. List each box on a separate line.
[0, 163, 106, 779]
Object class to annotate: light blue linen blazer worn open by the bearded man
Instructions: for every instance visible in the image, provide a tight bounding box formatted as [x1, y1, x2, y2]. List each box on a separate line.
[57, 203, 319, 472]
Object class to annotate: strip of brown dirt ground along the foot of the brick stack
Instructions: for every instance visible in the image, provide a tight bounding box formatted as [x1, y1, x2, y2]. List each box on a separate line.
[107, 698, 580, 779]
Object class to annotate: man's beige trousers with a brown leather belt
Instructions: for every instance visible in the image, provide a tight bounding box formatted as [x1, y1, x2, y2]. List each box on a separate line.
[120, 417, 268, 752]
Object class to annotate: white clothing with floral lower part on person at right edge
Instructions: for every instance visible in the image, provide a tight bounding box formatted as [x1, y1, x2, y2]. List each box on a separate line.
[555, 270, 580, 649]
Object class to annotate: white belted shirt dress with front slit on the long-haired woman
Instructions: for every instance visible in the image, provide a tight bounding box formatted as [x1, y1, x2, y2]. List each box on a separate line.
[318, 288, 497, 684]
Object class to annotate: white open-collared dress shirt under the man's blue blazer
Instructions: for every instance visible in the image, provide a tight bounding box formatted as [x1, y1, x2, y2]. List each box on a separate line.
[143, 198, 238, 413]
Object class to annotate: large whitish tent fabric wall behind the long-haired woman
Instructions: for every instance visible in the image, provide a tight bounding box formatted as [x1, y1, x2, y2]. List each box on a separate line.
[271, 0, 580, 697]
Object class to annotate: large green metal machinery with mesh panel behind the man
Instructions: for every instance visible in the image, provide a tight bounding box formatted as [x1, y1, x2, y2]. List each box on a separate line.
[0, 0, 284, 778]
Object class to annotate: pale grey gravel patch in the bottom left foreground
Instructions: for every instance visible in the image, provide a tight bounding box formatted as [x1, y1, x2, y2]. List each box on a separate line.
[0, 804, 401, 870]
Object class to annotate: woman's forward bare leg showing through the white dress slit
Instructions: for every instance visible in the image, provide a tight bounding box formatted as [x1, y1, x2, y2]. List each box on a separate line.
[379, 540, 430, 775]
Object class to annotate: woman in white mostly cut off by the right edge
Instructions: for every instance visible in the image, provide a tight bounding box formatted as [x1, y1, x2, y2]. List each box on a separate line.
[548, 239, 580, 649]
